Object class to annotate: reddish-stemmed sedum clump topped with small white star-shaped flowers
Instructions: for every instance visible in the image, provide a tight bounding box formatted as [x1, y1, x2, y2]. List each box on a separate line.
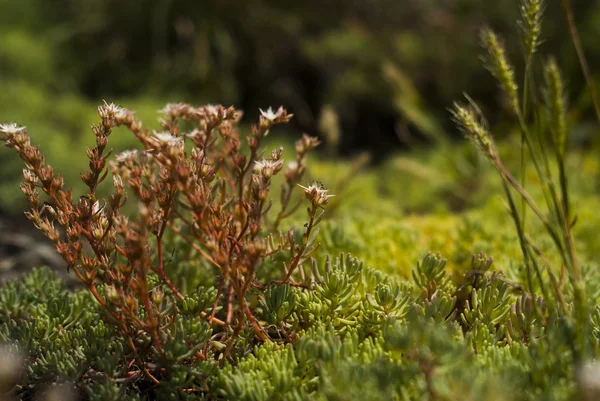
[0, 104, 332, 384]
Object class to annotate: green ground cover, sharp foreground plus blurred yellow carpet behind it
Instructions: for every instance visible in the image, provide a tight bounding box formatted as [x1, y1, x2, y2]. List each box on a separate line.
[0, 135, 600, 400]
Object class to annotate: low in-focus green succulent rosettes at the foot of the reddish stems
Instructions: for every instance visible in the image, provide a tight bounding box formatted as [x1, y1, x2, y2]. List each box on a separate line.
[0, 248, 598, 401]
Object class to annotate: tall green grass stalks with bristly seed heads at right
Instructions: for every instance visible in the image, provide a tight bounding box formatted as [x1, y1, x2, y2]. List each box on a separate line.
[452, 0, 600, 359]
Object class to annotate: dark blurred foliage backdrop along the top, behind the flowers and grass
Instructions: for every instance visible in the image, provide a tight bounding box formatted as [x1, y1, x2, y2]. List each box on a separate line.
[0, 0, 600, 157]
